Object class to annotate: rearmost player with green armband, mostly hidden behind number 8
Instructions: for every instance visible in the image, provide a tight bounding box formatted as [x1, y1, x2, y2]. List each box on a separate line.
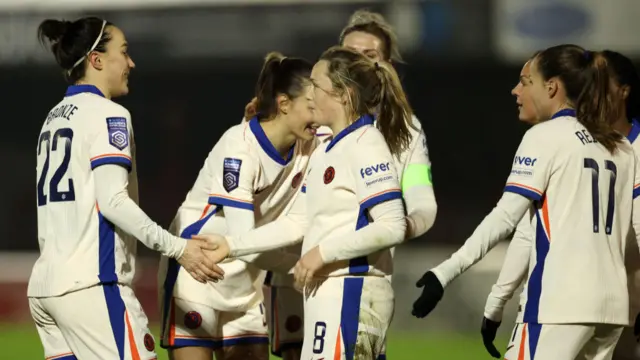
[268, 10, 437, 360]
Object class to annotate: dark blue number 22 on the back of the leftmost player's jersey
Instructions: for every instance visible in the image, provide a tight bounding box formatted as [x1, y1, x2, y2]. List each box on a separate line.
[38, 128, 76, 206]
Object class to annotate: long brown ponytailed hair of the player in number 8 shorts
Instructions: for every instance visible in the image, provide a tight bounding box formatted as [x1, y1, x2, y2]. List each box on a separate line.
[320, 46, 412, 156]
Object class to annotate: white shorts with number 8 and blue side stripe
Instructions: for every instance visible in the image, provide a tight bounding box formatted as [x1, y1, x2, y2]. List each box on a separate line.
[301, 276, 394, 360]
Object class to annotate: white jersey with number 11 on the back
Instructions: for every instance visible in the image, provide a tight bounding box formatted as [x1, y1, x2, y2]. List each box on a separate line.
[505, 110, 640, 325]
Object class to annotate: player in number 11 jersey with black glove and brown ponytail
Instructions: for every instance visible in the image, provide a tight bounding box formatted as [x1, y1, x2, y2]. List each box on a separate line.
[414, 45, 640, 360]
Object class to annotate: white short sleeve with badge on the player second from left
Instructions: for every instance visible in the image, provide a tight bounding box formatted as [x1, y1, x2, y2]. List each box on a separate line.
[207, 141, 259, 211]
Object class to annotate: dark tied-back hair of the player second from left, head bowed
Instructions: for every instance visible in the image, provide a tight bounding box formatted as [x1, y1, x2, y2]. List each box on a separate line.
[255, 52, 313, 120]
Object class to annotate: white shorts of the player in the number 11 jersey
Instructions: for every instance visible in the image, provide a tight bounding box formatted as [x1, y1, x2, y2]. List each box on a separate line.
[504, 323, 623, 360]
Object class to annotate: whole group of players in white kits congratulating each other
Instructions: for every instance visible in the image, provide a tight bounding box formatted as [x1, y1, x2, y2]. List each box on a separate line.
[28, 10, 640, 360]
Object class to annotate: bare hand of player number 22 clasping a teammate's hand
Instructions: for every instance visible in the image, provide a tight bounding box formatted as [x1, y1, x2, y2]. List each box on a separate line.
[177, 239, 224, 283]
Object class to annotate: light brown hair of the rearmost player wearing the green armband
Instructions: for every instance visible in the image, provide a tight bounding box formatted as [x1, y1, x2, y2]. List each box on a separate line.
[338, 9, 403, 63]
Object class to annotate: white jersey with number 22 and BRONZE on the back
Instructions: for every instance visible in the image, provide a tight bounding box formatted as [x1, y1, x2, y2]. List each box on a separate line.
[28, 85, 138, 297]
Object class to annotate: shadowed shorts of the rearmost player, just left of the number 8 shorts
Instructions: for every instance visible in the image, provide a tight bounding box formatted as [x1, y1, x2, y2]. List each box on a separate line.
[269, 286, 304, 357]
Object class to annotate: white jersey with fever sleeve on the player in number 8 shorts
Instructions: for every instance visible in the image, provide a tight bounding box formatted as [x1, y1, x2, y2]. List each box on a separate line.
[300, 116, 402, 276]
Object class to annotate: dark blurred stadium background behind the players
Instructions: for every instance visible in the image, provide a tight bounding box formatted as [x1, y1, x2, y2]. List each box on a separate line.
[0, 0, 636, 251]
